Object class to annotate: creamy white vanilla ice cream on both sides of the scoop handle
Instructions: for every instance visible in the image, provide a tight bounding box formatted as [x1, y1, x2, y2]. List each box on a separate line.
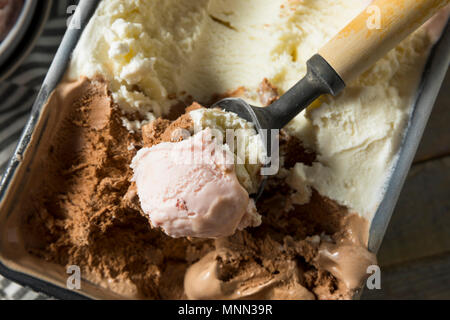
[69, 0, 429, 220]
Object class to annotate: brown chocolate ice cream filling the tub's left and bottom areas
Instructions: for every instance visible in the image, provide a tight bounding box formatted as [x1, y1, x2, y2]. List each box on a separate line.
[23, 78, 375, 299]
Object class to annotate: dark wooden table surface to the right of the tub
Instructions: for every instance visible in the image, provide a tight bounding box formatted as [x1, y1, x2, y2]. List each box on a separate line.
[362, 72, 450, 299]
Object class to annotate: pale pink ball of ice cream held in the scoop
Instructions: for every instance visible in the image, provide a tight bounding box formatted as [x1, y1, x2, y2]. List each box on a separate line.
[131, 129, 261, 238]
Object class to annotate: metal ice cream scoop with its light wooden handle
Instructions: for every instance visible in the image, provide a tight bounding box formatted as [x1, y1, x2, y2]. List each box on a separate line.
[213, 0, 449, 194]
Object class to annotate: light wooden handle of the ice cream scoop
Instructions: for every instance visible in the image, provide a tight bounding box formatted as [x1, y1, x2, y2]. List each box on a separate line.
[319, 0, 450, 83]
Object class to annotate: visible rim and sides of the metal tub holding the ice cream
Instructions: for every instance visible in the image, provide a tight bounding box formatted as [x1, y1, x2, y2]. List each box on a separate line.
[0, 0, 450, 299]
